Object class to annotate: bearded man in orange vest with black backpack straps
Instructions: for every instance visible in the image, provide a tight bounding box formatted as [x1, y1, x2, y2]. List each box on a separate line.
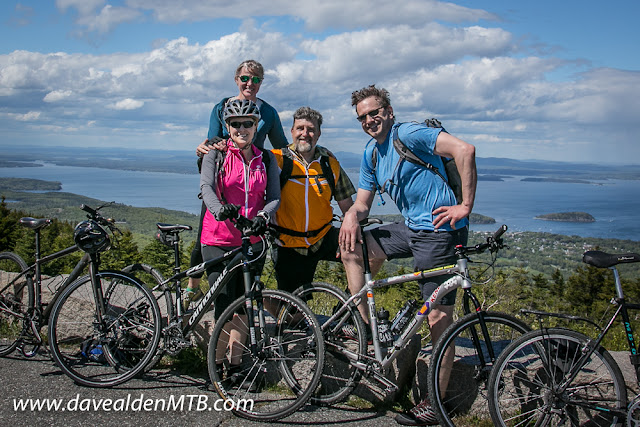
[271, 107, 356, 292]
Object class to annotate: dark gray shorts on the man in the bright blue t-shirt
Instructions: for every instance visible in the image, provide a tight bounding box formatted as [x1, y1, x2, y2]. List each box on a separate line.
[367, 222, 469, 305]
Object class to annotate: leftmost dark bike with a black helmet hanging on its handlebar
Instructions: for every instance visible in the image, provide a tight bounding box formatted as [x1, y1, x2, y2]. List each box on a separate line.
[0, 205, 160, 387]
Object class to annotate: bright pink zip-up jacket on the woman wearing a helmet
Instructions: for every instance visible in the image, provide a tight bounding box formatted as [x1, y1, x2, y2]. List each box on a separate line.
[201, 144, 267, 246]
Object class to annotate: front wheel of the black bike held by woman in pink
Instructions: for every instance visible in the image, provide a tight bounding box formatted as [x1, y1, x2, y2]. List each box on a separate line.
[207, 290, 325, 421]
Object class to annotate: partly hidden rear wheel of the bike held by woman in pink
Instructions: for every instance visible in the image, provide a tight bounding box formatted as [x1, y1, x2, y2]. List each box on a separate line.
[122, 263, 175, 372]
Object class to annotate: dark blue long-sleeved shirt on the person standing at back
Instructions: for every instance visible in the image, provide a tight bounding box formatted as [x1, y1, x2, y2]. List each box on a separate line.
[207, 98, 289, 149]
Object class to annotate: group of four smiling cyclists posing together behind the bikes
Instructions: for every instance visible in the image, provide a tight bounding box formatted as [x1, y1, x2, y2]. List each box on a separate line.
[187, 60, 477, 425]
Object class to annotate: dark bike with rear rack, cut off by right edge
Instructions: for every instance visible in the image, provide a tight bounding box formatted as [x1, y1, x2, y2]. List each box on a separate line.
[489, 251, 640, 426]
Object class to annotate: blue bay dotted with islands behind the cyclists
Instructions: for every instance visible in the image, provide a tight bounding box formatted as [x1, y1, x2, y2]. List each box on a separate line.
[0, 147, 640, 241]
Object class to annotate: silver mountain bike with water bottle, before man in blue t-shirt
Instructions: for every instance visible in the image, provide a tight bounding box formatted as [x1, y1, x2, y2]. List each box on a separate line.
[295, 219, 529, 425]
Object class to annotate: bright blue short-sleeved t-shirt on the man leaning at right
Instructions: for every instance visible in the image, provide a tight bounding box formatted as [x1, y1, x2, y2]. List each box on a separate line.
[358, 122, 469, 231]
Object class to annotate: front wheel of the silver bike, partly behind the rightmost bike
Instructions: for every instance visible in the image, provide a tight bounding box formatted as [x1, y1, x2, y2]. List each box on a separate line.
[428, 312, 530, 426]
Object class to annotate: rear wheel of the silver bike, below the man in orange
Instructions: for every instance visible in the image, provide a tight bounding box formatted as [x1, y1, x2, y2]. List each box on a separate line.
[294, 282, 367, 405]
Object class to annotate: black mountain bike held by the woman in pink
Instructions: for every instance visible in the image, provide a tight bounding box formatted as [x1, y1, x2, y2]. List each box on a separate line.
[132, 209, 325, 421]
